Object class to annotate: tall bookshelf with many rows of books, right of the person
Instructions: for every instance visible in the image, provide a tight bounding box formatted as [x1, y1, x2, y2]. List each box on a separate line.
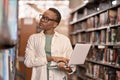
[69, 0, 120, 80]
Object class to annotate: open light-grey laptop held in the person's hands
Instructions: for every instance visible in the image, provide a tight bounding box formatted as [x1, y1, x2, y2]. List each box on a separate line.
[49, 43, 91, 69]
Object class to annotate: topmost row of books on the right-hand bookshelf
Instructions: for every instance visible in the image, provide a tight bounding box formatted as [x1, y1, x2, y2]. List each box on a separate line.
[71, 0, 120, 22]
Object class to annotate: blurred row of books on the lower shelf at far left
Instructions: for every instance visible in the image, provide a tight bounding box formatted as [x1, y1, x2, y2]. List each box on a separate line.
[0, 48, 16, 80]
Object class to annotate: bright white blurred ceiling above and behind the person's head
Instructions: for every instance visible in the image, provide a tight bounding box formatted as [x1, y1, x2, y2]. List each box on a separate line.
[19, 0, 70, 19]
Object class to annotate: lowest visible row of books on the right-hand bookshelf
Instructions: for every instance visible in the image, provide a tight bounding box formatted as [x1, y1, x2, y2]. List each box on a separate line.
[86, 63, 120, 80]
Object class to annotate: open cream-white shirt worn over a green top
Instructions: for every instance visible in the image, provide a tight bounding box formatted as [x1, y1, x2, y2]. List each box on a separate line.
[24, 31, 73, 80]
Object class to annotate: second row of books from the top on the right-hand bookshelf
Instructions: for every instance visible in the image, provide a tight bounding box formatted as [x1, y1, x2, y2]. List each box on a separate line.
[73, 7, 120, 31]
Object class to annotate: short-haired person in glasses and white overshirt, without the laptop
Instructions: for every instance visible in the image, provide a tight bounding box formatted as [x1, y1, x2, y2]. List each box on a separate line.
[24, 8, 73, 80]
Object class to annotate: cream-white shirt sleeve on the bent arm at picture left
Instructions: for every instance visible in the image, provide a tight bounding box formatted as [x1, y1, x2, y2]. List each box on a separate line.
[24, 36, 47, 67]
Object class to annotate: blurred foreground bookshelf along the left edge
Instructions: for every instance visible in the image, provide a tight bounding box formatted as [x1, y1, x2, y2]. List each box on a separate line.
[0, 0, 18, 80]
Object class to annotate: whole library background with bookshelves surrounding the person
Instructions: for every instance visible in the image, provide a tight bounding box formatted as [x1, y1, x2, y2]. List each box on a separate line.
[0, 0, 120, 80]
